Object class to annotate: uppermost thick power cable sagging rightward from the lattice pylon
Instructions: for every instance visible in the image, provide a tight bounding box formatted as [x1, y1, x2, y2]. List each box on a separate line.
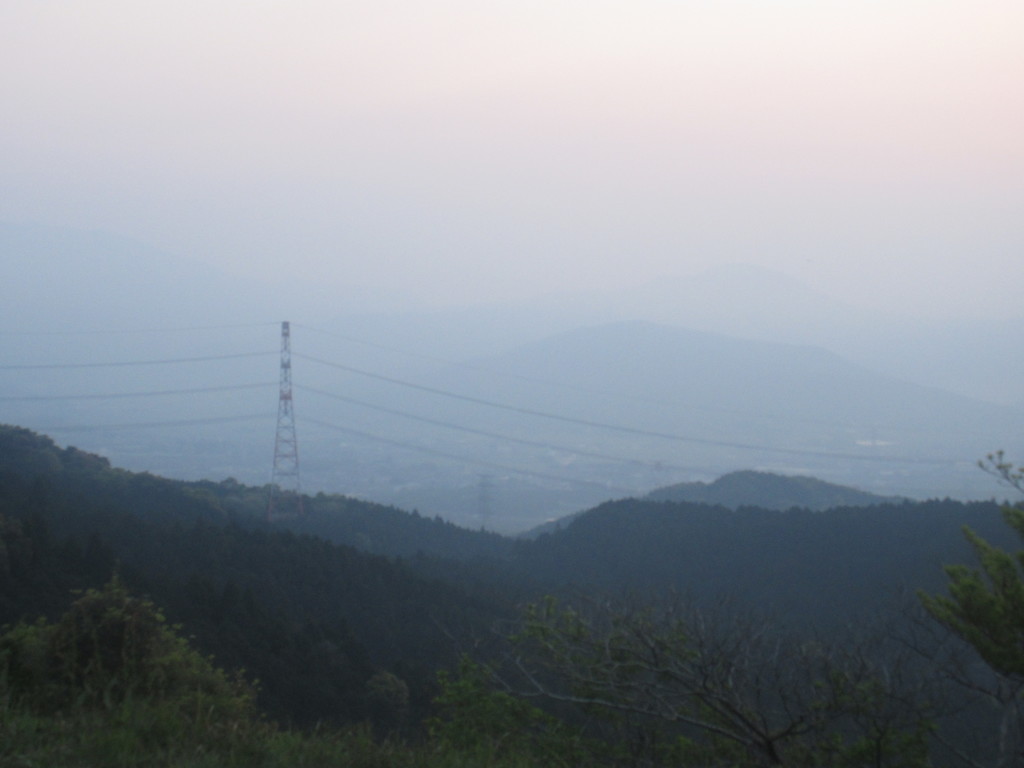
[293, 352, 955, 465]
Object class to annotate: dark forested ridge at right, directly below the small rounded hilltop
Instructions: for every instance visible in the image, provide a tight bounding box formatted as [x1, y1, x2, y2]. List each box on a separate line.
[519, 500, 1013, 627]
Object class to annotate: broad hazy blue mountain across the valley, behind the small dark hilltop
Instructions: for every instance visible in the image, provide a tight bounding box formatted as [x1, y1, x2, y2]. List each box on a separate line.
[448, 322, 1024, 512]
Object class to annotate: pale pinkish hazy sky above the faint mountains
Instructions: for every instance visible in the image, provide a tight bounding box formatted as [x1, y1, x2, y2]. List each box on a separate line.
[0, 0, 1024, 315]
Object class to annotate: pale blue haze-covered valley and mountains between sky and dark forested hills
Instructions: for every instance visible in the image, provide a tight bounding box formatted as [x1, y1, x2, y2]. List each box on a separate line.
[0, 224, 1024, 532]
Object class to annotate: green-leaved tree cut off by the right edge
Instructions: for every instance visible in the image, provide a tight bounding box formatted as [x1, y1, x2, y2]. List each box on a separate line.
[920, 452, 1024, 768]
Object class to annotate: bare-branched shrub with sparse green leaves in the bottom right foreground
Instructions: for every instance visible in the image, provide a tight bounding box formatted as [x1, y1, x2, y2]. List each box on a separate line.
[495, 599, 930, 767]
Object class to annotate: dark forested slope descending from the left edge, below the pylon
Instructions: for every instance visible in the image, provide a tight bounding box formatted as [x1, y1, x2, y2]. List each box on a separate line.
[0, 427, 506, 722]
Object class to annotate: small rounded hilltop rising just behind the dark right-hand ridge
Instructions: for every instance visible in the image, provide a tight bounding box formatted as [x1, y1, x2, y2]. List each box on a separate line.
[644, 470, 900, 511]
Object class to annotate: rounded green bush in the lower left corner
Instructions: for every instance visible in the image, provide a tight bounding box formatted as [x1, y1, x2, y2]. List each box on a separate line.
[0, 579, 267, 766]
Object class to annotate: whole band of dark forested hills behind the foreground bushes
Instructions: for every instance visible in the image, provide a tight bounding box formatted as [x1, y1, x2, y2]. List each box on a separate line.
[0, 427, 1018, 733]
